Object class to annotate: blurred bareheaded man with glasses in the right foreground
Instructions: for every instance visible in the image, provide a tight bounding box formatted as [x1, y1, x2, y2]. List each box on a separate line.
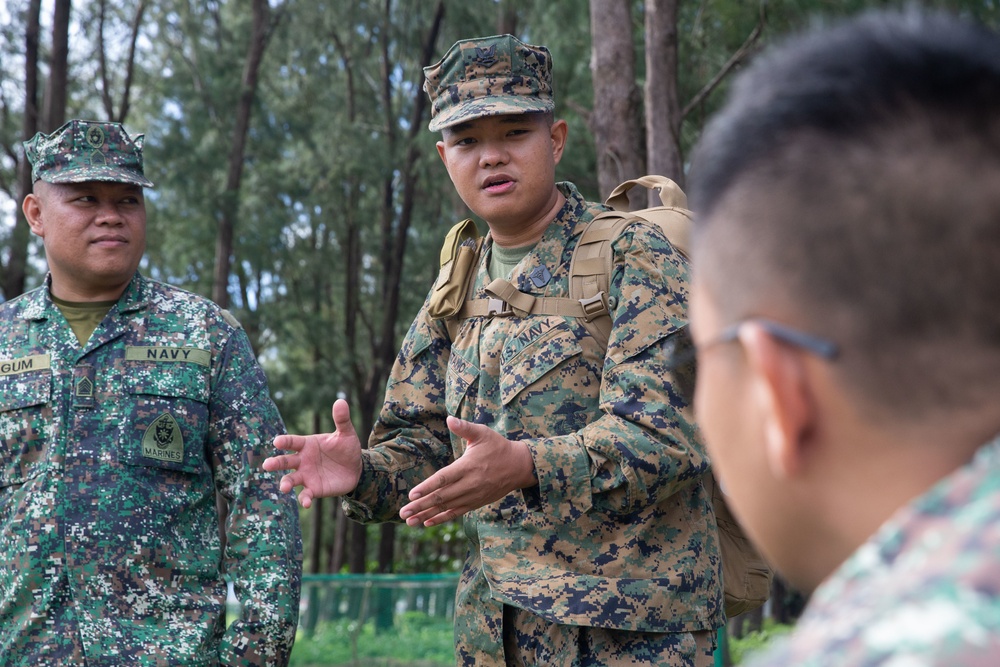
[691, 12, 1000, 667]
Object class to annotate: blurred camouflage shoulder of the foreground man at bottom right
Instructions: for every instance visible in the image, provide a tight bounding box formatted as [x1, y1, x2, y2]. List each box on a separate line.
[752, 437, 1000, 667]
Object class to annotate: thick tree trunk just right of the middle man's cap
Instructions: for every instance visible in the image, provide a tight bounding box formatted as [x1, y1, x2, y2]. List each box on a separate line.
[590, 0, 646, 208]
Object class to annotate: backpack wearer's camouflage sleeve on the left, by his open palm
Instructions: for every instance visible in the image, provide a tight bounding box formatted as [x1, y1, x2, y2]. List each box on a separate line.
[344, 302, 453, 522]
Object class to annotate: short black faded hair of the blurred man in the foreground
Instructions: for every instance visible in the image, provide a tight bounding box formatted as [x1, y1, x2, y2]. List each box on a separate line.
[689, 9, 1000, 414]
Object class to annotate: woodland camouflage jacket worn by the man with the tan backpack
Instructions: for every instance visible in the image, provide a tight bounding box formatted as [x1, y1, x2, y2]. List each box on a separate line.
[345, 184, 724, 665]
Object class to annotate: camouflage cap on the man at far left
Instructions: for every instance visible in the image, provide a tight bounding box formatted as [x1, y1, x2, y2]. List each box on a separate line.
[24, 120, 153, 188]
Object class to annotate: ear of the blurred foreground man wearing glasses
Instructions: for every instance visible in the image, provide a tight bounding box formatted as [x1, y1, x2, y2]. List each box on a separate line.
[740, 321, 816, 479]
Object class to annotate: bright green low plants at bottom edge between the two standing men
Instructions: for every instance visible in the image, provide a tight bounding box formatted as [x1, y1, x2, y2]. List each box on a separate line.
[289, 612, 455, 667]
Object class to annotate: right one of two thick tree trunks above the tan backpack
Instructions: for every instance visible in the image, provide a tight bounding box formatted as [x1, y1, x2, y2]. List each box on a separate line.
[645, 0, 684, 196]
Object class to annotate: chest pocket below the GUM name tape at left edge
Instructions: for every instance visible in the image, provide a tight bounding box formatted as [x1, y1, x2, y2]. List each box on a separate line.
[0, 370, 52, 487]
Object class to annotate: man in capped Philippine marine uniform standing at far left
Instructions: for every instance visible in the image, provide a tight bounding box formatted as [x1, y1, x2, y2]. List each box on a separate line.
[0, 120, 301, 667]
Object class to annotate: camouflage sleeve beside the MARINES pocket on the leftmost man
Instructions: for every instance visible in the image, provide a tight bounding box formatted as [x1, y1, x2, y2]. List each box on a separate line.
[209, 329, 302, 667]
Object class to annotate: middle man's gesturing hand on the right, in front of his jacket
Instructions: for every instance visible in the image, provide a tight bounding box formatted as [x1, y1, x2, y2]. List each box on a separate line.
[399, 417, 538, 526]
